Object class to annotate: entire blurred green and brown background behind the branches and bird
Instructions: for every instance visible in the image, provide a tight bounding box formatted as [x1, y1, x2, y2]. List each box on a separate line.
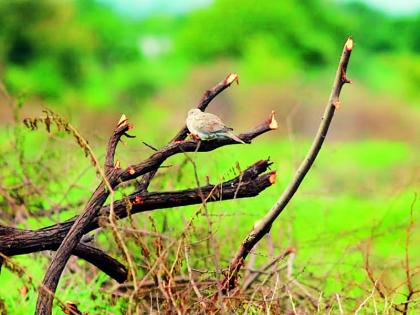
[0, 0, 420, 314]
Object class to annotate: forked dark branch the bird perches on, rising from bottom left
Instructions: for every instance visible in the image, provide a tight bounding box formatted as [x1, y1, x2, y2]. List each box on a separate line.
[23, 74, 277, 315]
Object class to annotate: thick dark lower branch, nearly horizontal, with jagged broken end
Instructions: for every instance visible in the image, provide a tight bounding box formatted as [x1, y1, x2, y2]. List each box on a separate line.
[0, 160, 276, 258]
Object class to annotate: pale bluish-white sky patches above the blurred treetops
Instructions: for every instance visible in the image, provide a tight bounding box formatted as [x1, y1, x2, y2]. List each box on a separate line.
[100, 0, 420, 17]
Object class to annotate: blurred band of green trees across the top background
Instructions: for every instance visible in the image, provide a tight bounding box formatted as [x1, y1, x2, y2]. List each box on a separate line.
[0, 0, 420, 108]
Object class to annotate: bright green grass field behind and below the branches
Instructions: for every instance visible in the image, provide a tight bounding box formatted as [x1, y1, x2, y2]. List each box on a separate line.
[0, 133, 420, 314]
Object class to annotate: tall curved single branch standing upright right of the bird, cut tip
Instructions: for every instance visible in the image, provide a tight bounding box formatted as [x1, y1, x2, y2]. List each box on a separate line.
[222, 37, 354, 292]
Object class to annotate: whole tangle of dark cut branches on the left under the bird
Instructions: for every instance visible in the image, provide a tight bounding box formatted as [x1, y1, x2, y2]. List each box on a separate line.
[0, 74, 277, 315]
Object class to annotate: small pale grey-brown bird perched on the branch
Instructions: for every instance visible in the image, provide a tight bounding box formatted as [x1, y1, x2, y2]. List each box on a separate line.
[186, 108, 245, 144]
